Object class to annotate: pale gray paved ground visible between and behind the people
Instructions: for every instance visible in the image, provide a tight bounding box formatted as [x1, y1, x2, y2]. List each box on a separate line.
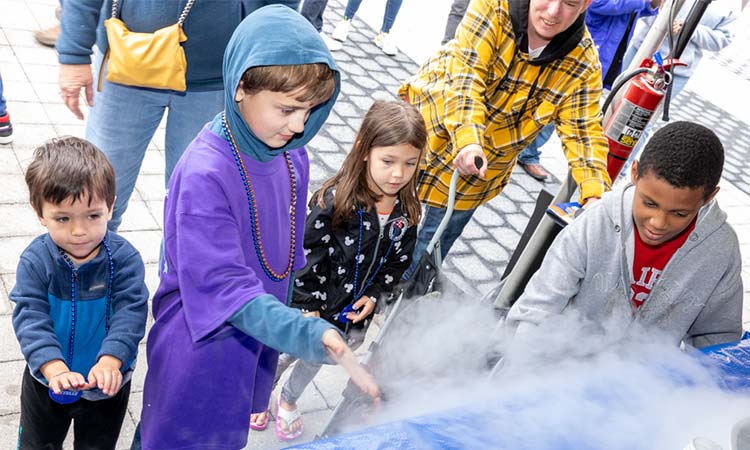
[0, 0, 750, 449]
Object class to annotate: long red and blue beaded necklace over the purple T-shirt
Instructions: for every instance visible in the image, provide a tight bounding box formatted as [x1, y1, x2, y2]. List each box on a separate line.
[221, 112, 297, 281]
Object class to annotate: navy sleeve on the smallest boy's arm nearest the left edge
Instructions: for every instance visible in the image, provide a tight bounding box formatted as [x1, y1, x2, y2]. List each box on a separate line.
[10, 250, 65, 379]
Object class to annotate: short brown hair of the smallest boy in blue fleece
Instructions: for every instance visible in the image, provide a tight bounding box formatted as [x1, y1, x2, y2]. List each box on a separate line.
[26, 136, 115, 217]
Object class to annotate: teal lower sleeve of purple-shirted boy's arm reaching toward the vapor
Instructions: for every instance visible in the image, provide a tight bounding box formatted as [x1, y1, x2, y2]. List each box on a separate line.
[229, 294, 335, 364]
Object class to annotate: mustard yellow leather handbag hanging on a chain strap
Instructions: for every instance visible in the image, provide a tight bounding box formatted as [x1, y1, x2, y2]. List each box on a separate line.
[99, 0, 195, 91]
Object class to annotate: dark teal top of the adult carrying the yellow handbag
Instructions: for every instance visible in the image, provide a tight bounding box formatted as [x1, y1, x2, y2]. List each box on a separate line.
[55, 0, 299, 91]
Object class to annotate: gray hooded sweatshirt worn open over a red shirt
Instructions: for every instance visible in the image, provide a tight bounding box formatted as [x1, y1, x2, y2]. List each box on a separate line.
[506, 185, 743, 348]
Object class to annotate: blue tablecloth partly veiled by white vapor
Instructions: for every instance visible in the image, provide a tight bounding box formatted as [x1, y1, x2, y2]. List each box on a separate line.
[291, 333, 750, 450]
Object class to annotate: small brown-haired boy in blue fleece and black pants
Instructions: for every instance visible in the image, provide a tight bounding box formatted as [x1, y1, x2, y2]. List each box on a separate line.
[10, 137, 148, 449]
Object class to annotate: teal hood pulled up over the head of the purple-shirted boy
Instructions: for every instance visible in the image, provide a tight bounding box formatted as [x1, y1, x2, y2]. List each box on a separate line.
[222, 5, 341, 160]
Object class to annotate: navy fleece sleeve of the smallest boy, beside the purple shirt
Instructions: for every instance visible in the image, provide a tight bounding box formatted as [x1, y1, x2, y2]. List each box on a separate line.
[96, 245, 148, 370]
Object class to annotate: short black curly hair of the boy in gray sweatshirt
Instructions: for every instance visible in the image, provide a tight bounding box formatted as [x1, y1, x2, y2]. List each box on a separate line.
[638, 121, 724, 197]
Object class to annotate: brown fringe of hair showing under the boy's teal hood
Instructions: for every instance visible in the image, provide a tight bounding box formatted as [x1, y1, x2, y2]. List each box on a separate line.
[241, 63, 336, 104]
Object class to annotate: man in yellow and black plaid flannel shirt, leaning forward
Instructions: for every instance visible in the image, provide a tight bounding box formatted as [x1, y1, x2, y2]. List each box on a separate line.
[399, 0, 610, 279]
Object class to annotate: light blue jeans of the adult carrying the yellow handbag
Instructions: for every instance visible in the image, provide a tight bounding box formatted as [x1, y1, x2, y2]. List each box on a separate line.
[86, 55, 224, 231]
